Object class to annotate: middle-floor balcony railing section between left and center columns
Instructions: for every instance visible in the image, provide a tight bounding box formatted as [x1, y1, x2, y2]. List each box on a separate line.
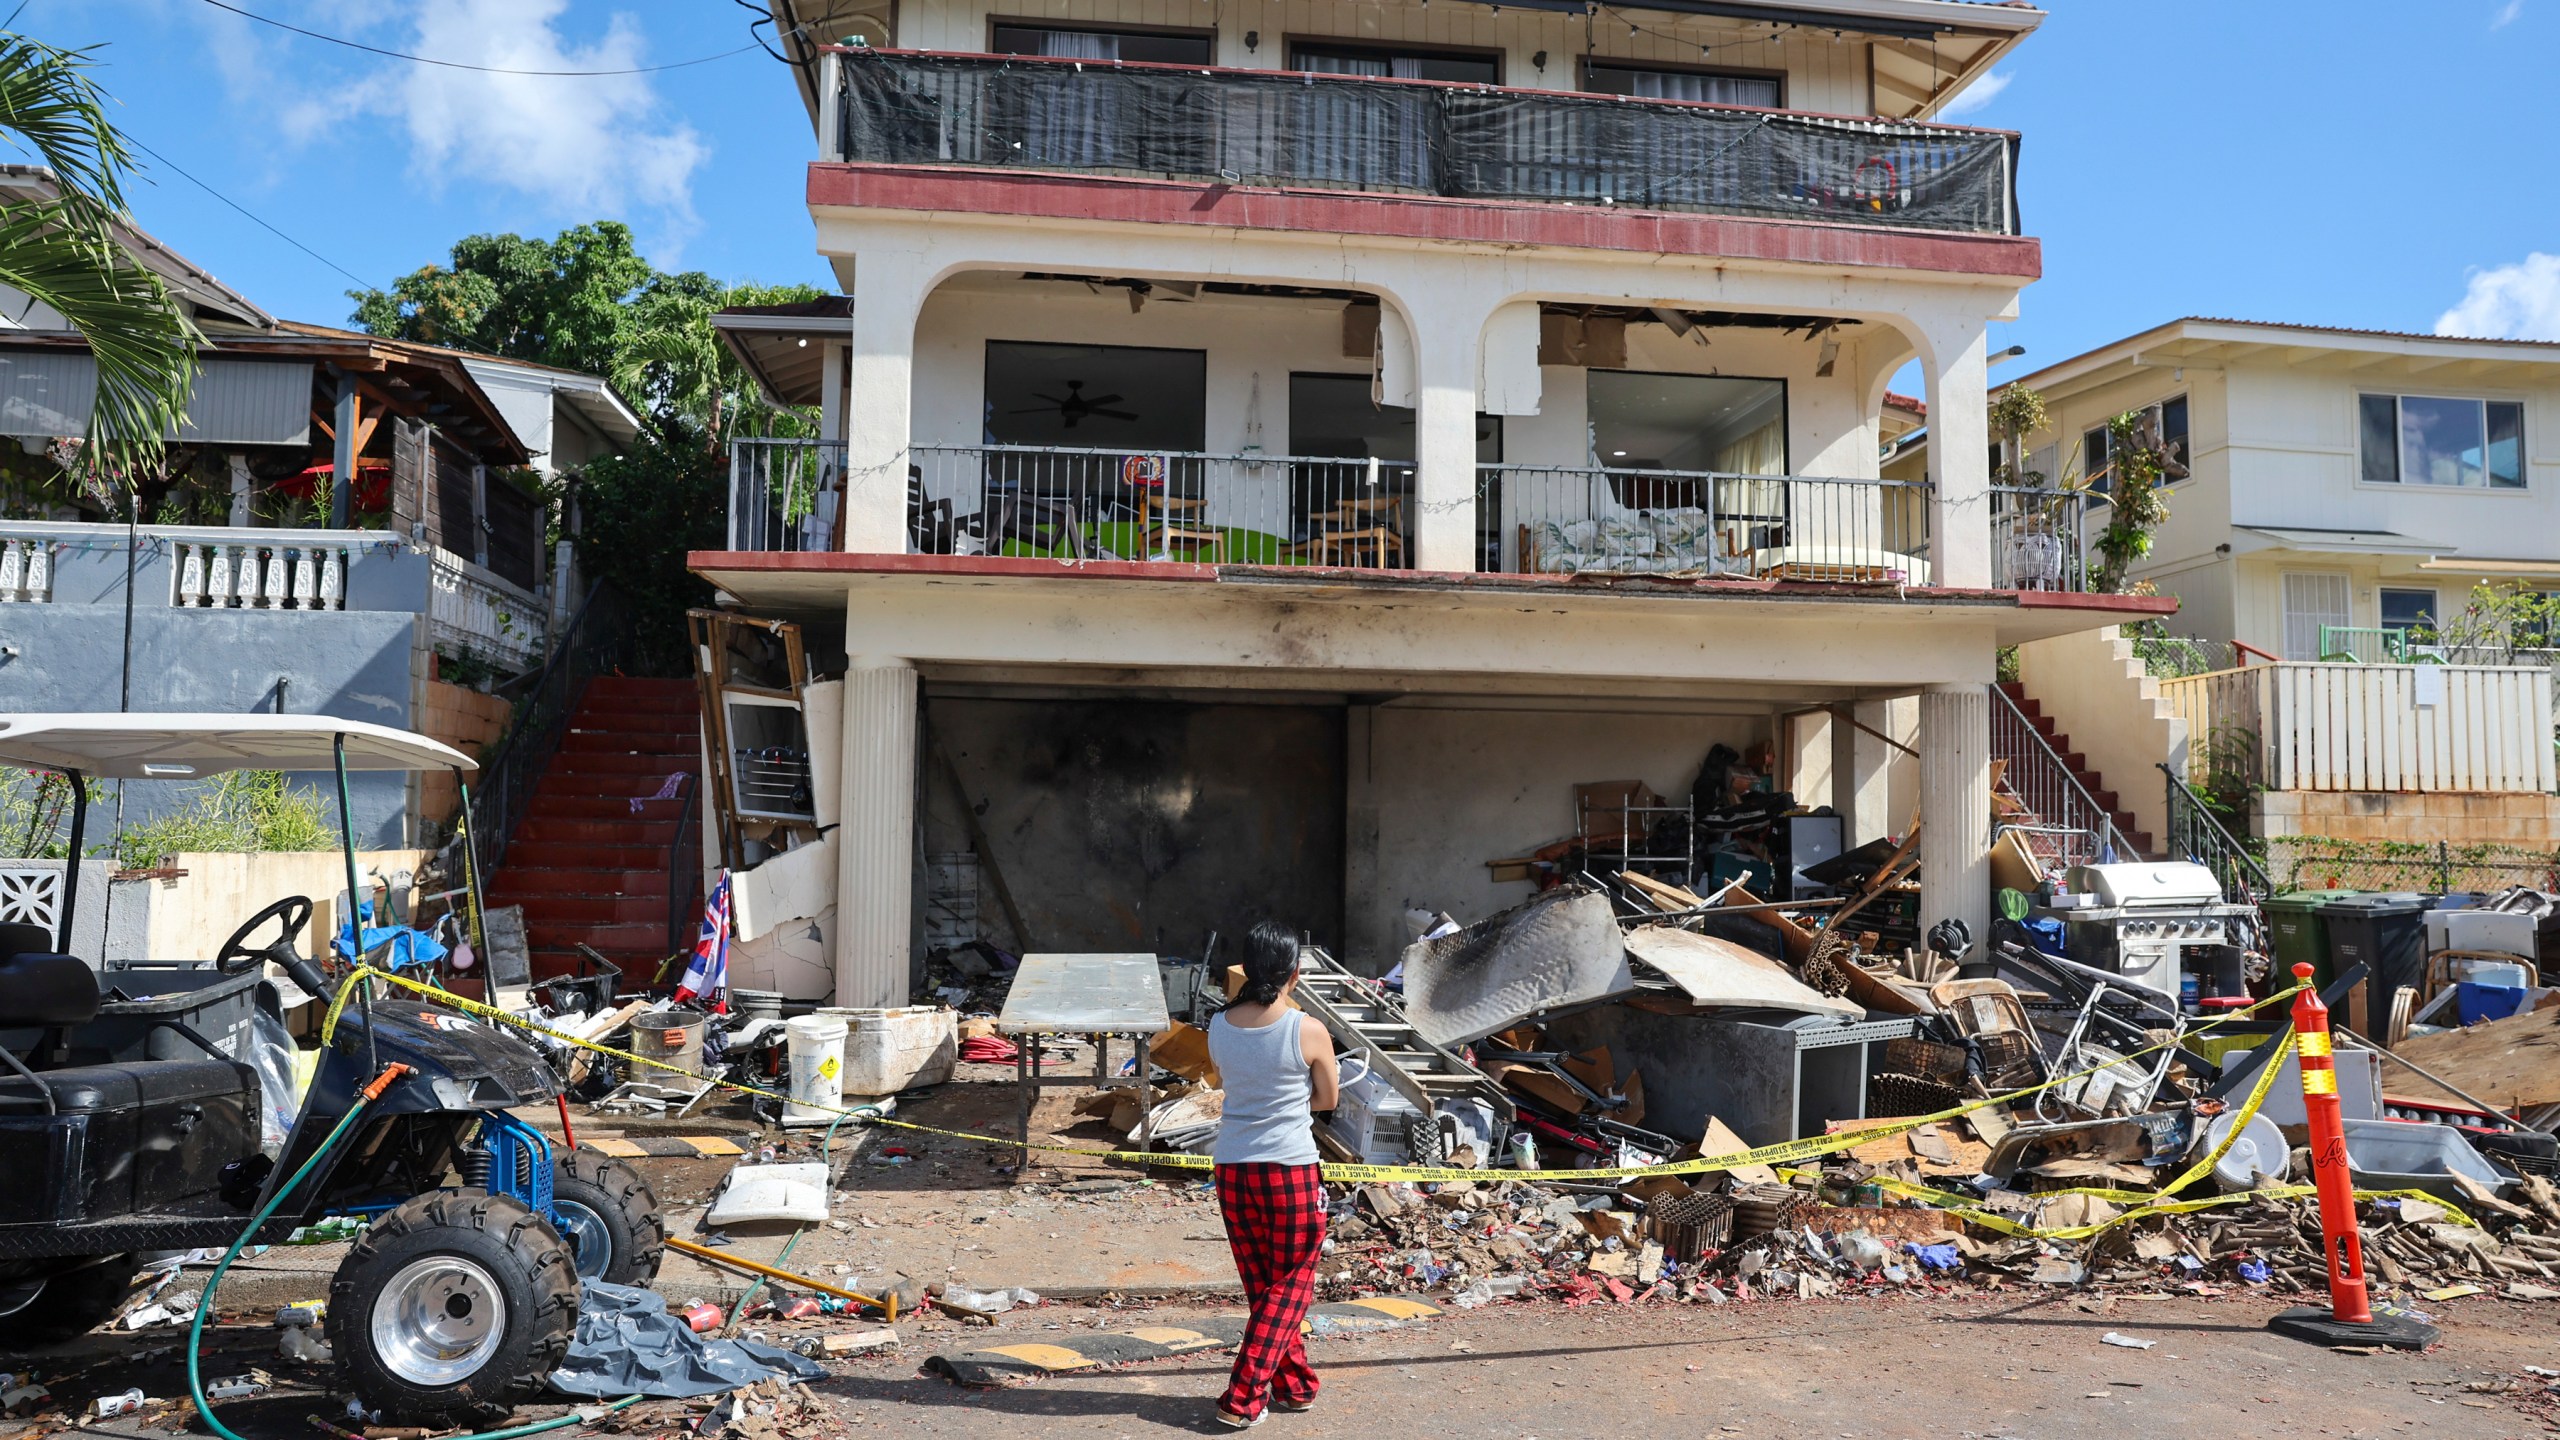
[906, 446, 1413, 569]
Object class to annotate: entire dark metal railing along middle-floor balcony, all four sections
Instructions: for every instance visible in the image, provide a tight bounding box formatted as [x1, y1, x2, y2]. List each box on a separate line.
[730, 438, 2119, 589]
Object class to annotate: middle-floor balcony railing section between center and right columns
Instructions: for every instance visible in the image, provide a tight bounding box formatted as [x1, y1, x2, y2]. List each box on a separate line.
[1475, 464, 1928, 584]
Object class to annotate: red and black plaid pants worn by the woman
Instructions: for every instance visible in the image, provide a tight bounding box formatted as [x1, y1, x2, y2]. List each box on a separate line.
[1219, 1163, 1324, 1420]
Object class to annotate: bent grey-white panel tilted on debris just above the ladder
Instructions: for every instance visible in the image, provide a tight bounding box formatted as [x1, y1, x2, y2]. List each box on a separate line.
[1405, 887, 1636, 1045]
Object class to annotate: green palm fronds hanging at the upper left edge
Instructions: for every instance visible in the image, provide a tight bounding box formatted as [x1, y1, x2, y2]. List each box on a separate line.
[0, 31, 200, 487]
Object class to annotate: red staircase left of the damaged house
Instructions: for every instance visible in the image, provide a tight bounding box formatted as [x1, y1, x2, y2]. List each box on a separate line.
[489, 674, 701, 973]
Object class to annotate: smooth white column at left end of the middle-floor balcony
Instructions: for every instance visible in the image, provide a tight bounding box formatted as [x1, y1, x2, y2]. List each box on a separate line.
[840, 251, 932, 553]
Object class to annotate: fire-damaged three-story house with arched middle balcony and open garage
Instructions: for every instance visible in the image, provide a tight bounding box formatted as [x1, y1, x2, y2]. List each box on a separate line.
[694, 0, 2168, 1004]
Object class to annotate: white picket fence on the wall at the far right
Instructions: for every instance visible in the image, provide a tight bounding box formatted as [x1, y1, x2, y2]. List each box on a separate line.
[2161, 661, 2555, 794]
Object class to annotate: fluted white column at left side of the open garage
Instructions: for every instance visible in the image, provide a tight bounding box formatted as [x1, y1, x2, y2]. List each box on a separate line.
[835, 656, 916, 1007]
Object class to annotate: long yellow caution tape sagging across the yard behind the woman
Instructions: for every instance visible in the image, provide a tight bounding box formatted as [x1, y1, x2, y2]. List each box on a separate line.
[320, 966, 2309, 1188]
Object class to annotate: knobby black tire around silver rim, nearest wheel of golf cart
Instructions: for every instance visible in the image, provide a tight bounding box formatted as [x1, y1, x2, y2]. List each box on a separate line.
[328, 1189, 579, 1427]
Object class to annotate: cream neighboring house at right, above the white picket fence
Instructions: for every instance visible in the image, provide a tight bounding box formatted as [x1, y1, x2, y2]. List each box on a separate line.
[2017, 318, 2560, 661]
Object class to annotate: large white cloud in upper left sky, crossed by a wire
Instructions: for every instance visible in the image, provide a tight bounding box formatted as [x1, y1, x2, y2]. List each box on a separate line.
[345, 0, 709, 251]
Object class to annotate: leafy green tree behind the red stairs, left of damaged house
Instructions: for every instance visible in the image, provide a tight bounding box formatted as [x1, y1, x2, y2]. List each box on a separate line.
[348, 220, 824, 674]
